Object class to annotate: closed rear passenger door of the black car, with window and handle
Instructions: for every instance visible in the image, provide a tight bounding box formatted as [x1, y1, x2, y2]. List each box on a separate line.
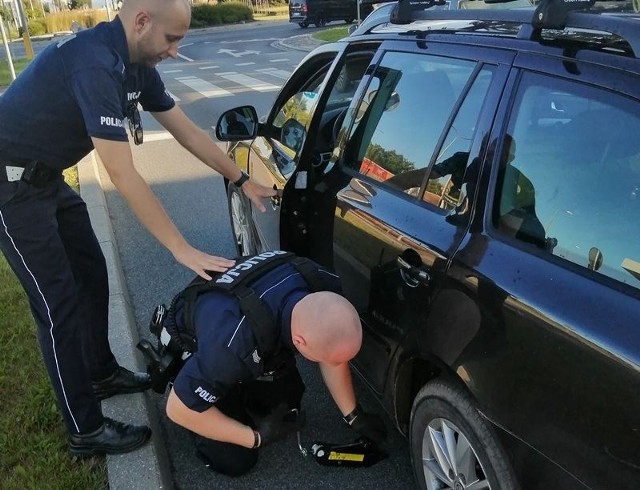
[312, 42, 510, 393]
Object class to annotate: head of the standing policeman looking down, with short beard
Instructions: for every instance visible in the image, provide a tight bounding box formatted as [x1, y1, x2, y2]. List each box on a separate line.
[118, 0, 191, 66]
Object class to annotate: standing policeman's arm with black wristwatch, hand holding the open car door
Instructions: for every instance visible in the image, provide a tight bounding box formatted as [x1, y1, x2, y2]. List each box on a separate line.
[152, 105, 276, 211]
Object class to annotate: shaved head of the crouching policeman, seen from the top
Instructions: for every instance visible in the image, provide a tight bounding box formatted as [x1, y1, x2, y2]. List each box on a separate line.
[291, 291, 362, 364]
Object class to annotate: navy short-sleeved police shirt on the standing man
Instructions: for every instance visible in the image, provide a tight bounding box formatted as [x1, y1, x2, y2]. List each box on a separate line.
[0, 17, 175, 169]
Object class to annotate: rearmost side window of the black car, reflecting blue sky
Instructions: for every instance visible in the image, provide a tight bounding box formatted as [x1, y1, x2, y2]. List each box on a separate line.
[494, 73, 640, 287]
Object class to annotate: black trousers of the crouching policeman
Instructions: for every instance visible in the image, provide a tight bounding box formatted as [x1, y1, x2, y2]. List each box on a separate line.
[194, 361, 305, 476]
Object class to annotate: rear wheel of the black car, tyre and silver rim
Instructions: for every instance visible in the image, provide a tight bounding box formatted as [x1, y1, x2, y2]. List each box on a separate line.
[409, 380, 518, 490]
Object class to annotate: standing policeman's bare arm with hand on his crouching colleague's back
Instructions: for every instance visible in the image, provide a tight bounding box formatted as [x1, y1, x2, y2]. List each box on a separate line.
[92, 138, 233, 279]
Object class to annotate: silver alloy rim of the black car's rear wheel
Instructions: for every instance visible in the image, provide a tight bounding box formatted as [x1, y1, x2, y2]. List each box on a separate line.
[422, 418, 491, 490]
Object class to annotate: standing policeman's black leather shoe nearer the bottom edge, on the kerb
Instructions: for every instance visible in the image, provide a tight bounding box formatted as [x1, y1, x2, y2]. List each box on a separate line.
[68, 417, 151, 457]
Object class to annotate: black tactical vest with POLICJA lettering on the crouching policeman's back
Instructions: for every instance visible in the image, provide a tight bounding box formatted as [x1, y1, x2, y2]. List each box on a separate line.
[165, 255, 341, 359]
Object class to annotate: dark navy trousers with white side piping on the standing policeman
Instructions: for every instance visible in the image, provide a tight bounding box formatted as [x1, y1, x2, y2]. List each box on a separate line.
[0, 176, 117, 433]
